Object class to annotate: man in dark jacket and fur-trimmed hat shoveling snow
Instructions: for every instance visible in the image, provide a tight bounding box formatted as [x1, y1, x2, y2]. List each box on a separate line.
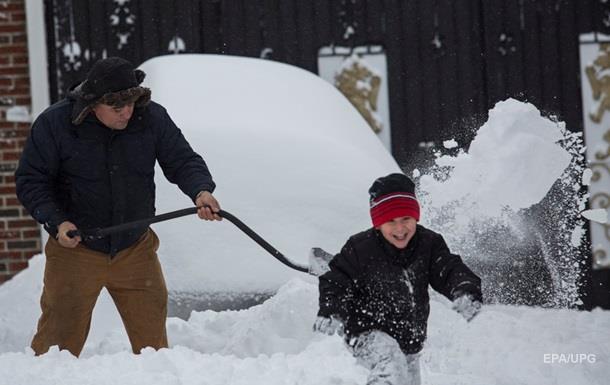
[15, 57, 221, 356]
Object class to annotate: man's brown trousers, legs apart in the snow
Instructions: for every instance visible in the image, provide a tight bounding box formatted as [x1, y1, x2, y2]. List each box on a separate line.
[32, 230, 167, 357]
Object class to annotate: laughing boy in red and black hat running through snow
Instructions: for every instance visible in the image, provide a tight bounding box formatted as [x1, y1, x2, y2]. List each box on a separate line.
[314, 174, 482, 385]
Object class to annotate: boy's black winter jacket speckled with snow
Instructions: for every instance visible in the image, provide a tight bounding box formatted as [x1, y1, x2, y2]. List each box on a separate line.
[318, 225, 482, 354]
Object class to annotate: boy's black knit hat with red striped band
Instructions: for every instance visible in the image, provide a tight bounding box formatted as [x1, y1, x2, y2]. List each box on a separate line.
[369, 173, 420, 227]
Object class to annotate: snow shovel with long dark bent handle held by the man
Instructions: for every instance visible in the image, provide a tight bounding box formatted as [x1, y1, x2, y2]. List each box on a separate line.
[67, 207, 333, 276]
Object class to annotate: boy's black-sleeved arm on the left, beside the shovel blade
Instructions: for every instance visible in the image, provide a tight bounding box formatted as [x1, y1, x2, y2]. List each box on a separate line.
[318, 241, 358, 320]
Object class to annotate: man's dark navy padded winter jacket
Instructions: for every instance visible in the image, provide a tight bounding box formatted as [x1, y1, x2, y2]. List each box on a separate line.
[15, 99, 215, 255]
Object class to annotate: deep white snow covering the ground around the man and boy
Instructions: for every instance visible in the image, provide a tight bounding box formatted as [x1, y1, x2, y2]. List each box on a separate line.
[0, 268, 610, 385]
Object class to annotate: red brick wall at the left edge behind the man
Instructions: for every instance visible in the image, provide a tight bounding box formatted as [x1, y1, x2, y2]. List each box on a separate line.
[0, 0, 41, 284]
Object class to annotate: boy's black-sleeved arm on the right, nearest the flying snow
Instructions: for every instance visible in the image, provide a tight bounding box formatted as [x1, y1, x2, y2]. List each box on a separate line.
[430, 235, 483, 302]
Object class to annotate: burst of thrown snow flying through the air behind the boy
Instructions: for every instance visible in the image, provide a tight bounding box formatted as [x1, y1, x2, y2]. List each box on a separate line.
[419, 99, 586, 306]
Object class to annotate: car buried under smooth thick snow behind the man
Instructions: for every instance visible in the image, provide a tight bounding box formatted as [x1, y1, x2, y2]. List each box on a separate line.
[141, 55, 399, 307]
